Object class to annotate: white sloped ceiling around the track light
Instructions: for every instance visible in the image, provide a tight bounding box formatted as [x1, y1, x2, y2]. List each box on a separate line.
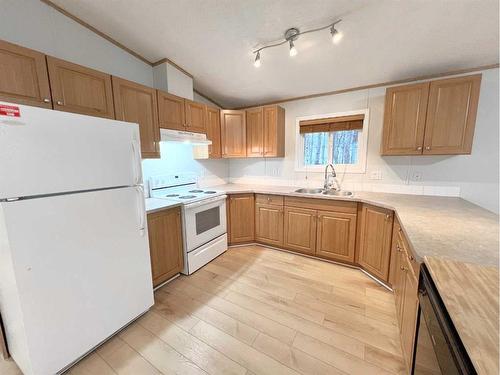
[52, 0, 499, 108]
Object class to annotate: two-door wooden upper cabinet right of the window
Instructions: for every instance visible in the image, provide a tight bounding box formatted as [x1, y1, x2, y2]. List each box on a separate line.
[381, 74, 481, 155]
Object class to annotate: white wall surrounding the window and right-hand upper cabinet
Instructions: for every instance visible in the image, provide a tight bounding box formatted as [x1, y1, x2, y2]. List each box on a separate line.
[229, 69, 499, 212]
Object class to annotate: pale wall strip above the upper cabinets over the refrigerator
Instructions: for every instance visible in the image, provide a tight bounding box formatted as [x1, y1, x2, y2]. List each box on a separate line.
[0, 0, 153, 86]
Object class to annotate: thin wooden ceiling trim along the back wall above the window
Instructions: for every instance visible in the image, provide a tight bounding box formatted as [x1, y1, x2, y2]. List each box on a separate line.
[233, 63, 500, 110]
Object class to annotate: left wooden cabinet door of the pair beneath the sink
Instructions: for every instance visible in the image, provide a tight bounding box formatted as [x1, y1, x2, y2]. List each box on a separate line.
[284, 207, 317, 255]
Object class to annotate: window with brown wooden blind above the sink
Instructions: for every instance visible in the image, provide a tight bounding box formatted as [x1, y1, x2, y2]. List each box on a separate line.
[296, 110, 367, 173]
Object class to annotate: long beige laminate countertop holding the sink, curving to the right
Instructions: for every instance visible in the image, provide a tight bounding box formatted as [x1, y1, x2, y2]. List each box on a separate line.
[213, 184, 499, 268]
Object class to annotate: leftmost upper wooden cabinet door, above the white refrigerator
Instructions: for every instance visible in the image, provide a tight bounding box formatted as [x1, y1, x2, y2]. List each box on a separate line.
[0, 40, 52, 108]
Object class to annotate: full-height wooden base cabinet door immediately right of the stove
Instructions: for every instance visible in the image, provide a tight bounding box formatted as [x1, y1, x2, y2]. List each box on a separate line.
[229, 194, 255, 244]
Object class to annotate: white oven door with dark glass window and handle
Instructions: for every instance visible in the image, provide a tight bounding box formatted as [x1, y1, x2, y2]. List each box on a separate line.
[184, 195, 227, 252]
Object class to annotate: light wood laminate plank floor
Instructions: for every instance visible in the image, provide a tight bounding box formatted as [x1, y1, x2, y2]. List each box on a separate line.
[0, 246, 405, 375]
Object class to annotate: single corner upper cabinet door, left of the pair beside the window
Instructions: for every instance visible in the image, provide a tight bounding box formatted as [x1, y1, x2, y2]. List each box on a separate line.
[220, 109, 247, 158]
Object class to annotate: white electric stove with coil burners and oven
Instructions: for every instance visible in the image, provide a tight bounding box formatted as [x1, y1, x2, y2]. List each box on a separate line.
[149, 173, 227, 275]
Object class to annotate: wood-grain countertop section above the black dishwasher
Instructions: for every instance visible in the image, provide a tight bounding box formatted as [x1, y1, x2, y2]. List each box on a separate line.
[425, 257, 499, 375]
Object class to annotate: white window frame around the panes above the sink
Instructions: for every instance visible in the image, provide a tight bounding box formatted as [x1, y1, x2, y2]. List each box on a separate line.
[295, 108, 370, 173]
